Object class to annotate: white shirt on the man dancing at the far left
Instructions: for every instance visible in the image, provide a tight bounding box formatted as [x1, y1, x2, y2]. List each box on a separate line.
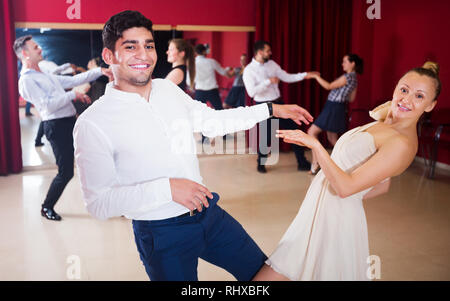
[19, 67, 102, 121]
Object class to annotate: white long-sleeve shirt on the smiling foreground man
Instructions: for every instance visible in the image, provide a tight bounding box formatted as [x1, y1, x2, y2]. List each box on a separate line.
[74, 79, 269, 220]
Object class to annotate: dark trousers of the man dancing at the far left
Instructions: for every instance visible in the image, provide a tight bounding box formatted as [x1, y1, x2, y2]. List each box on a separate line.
[42, 117, 76, 209]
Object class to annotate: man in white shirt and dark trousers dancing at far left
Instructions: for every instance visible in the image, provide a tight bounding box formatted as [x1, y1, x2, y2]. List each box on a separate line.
[13, 36, 107, 221]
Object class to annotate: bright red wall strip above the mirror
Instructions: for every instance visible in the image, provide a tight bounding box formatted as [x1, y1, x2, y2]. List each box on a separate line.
[13, 0, 256, 26]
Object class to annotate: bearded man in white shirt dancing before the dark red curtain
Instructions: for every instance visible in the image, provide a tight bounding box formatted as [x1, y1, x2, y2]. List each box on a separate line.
[243, 41, 316, 173]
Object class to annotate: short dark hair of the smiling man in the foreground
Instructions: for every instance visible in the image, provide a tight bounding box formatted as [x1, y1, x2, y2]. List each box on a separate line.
[102, 10, 153, 51]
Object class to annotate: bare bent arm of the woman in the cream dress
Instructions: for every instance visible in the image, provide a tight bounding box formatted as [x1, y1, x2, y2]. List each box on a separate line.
[278, 130, 415, 198]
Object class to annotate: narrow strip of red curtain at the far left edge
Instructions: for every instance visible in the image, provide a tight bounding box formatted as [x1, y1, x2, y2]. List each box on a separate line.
[0, 0, 22, 175]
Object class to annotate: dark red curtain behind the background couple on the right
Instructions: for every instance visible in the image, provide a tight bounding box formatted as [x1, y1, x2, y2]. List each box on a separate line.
[255, 0, 352, 150]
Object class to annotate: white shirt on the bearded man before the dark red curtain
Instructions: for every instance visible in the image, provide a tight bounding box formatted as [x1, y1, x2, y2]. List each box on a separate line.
[242, 58, 307, 102]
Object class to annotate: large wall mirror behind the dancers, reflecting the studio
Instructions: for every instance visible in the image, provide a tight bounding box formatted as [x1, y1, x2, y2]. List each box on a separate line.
[16, 28, 252, 170]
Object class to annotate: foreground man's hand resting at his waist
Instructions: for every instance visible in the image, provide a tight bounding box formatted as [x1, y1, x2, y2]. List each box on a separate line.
[169, 178, 213, 212]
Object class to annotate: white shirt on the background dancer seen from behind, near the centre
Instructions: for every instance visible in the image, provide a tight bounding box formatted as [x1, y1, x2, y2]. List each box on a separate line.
[195, 55, 227, 90]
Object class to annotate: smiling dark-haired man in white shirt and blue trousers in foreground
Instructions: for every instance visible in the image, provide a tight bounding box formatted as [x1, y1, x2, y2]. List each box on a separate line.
[74, 11, 312, 280]
